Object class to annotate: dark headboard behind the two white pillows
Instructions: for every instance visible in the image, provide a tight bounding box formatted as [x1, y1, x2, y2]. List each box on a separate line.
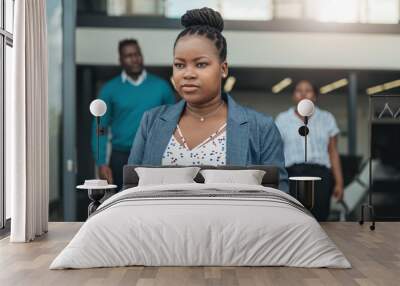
[122, 165, 279, 190]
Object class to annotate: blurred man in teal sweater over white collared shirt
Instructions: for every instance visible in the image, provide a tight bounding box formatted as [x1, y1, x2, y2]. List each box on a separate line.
[92, 39, 175, 189]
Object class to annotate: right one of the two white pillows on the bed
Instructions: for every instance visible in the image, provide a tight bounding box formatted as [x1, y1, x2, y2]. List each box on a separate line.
[200, 169, 265, 185]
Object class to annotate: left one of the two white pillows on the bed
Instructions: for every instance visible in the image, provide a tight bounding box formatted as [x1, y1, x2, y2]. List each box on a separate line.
[135, 167, 200, 186]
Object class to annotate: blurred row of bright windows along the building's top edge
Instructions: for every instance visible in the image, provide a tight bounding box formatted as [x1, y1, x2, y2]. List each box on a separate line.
[79, 0, 400, 24]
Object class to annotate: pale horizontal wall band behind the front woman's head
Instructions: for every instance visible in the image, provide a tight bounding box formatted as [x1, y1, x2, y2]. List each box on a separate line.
[76, 28, 400, 70]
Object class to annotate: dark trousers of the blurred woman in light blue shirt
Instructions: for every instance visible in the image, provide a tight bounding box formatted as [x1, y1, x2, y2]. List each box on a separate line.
[286, 164, 334, 221]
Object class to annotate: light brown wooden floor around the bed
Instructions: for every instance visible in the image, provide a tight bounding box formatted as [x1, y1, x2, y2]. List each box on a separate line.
[0, 222, 400, 286]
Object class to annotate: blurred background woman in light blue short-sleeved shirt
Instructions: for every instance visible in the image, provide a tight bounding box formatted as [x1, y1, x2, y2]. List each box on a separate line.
[276, 80, 343, 221]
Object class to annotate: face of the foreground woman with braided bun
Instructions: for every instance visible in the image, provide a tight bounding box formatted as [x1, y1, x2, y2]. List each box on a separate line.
[172, 35, 228, 104]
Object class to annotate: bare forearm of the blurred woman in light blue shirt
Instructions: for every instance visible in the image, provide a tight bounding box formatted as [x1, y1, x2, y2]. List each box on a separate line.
[328, 136, 344, 200]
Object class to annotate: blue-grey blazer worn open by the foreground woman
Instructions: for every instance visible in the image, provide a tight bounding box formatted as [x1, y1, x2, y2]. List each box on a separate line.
[128, 94, 288, 192]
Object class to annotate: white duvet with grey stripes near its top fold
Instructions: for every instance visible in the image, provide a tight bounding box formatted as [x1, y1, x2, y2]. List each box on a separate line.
[50, 183, 351, 269]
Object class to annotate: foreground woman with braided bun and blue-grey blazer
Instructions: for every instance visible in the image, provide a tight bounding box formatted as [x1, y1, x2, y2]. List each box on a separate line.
[128, 8, 288, 192]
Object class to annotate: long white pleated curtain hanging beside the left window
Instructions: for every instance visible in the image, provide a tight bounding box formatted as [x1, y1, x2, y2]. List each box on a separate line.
[6, 0, 49, 242]
